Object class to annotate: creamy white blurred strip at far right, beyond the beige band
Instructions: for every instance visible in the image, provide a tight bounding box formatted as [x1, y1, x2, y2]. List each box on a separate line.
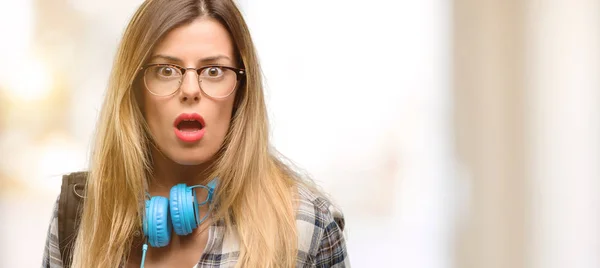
[527, 0, 600, 268]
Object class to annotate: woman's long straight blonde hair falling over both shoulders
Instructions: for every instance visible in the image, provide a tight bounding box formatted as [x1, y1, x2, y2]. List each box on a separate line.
[73, 0, 301, 268]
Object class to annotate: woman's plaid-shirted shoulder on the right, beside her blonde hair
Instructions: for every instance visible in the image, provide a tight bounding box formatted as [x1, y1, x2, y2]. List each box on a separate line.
[296, 185, 350, 267]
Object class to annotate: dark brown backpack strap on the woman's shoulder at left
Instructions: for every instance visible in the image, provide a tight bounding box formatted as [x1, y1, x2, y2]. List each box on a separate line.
[58, 171, 88, 267]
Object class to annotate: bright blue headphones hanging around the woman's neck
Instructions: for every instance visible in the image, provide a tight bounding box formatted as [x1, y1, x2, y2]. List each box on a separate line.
[143, 178, 217, 247]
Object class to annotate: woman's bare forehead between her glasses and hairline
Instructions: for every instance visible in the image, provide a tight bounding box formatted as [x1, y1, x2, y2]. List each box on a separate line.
[152, 17, 234, 64]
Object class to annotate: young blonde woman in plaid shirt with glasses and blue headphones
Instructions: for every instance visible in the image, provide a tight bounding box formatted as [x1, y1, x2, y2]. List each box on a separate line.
[43, 0, 350, 268]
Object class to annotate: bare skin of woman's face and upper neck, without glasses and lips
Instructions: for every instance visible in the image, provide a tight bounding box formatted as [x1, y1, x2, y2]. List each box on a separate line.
[143, 18, 237, 193]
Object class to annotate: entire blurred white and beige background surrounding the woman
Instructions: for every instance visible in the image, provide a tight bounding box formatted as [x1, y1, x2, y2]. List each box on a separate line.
[0, 0, 600, 268]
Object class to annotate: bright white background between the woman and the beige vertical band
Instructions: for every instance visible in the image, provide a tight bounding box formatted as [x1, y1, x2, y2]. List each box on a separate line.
[242, 0, 454, 268]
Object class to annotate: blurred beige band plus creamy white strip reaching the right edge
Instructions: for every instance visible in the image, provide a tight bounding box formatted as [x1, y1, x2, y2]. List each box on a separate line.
[453, 0, 600, 268]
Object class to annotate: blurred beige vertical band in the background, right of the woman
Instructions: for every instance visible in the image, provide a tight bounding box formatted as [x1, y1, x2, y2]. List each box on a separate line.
[453, 0, 528, 268]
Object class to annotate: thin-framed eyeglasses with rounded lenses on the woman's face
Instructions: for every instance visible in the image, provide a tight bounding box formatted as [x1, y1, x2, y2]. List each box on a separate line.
[140, 64, 246, 98]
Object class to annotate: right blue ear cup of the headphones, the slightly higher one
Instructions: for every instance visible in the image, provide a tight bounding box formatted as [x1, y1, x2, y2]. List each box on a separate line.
[169, 184, 198, 235]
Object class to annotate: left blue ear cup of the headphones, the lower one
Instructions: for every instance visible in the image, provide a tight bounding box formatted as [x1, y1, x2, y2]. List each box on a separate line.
[143, 196, 173, 247]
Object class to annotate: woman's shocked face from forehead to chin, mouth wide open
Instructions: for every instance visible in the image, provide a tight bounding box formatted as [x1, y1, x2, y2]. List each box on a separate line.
[143, 18, 238, 165]
